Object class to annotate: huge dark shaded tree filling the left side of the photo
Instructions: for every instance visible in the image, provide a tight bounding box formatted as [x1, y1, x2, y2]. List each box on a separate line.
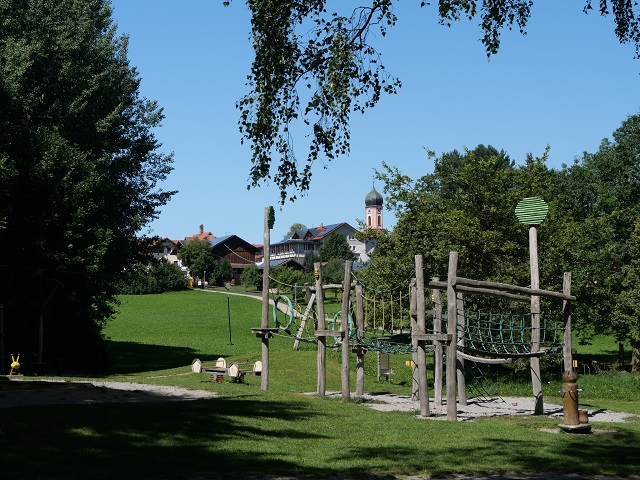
[0, 0, 173, 369]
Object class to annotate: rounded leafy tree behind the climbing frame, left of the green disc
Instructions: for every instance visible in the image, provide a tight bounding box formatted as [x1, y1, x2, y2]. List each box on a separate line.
[364, 145, 543, 288]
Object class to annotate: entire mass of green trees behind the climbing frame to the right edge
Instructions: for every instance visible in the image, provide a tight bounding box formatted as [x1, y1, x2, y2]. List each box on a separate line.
[361, 115, 640, 370]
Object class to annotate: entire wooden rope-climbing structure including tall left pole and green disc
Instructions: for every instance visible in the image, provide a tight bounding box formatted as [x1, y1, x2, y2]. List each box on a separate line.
[252, 199, 578, 428]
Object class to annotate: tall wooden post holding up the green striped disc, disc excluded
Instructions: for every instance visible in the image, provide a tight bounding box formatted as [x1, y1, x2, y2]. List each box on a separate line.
[529, 227, 544, 415]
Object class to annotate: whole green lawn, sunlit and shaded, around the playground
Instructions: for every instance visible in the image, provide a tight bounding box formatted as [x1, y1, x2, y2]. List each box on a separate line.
[0, 291, 640, 479]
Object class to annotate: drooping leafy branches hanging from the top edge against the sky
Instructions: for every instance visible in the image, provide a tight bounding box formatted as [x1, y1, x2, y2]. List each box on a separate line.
[232, 0, 640, 202]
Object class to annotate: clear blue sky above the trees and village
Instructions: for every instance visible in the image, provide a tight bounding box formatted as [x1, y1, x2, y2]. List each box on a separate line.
[112, 0, 640, 243]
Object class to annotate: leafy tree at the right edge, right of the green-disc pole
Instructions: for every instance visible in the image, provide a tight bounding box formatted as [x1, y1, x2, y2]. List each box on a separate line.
[551, 115, 640, 362]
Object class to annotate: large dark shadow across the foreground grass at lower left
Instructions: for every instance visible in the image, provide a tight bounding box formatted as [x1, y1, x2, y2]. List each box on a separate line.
[0, 396, 326, 479]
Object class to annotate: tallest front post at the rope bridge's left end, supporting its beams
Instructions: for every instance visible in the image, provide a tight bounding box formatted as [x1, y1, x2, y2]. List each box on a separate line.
[447, 252, 458, 421]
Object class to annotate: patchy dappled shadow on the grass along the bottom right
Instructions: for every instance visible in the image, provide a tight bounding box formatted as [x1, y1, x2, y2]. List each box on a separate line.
[337, 430, 640, 480]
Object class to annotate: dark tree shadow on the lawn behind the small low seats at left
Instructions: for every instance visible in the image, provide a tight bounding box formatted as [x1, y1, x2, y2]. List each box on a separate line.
[107, 340, 222, 374]
